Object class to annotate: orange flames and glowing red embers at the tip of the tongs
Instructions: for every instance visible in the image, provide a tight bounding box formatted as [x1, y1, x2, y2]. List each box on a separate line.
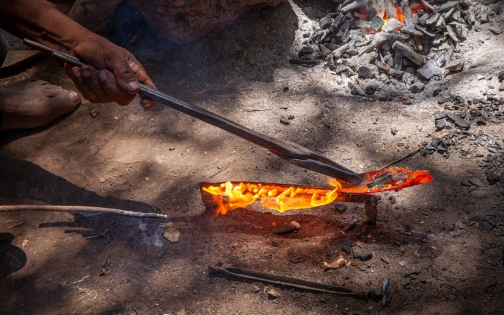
[202, 168, 432, 215]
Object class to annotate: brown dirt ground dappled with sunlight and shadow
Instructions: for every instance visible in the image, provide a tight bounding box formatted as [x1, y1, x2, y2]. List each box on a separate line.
[0, 1, 504, 315]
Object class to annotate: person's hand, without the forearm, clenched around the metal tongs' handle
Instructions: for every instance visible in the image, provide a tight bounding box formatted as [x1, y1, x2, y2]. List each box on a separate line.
[65, 35, 157, 110]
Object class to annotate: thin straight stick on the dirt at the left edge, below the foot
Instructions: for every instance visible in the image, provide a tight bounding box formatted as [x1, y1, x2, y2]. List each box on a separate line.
[0, 205, 168, 219]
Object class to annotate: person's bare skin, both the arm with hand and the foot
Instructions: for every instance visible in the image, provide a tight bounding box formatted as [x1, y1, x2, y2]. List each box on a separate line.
[0, 0, 157, 131]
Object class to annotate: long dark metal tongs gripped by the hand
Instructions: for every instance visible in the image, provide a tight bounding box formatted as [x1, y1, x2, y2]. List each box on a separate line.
[23, 39, 366, 187]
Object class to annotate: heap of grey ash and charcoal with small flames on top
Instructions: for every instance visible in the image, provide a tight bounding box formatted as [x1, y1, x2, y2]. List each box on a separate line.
[291, 0, 500, 96]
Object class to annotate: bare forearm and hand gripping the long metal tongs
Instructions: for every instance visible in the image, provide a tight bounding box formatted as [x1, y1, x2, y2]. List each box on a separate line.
[0, 0, 156, 109]
